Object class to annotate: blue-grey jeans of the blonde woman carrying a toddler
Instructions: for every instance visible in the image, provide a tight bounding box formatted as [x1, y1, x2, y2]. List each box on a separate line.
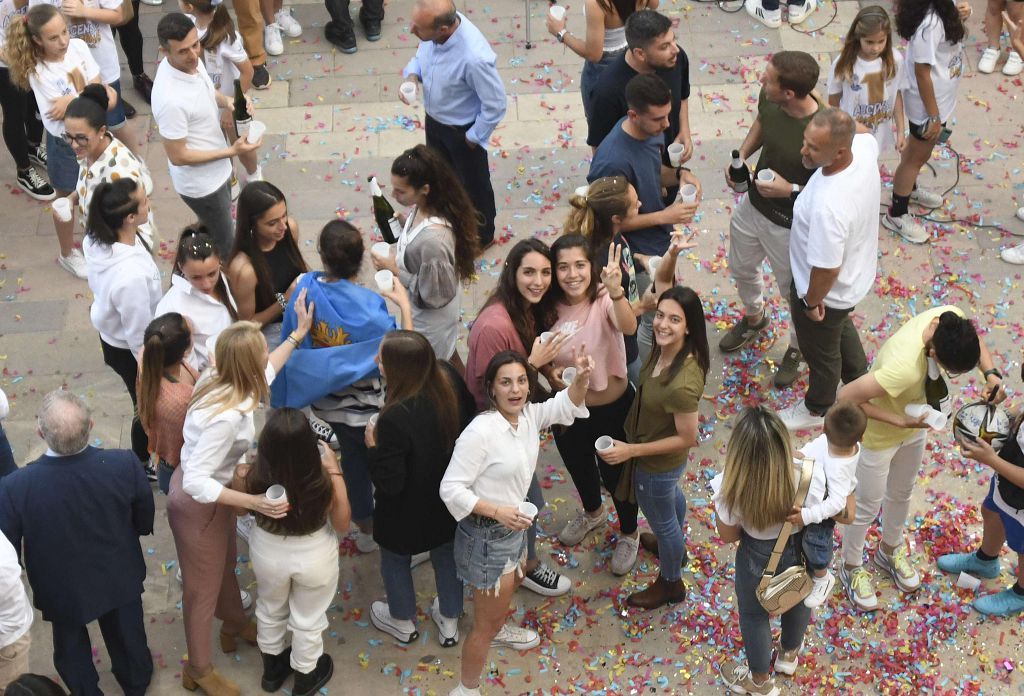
[736, 531, 811, 675]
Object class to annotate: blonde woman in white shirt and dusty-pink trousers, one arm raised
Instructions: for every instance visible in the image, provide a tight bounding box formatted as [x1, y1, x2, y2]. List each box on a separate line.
[167, 292, 313, 696]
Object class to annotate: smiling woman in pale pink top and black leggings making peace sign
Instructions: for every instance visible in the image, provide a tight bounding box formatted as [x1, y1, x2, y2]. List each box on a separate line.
[550, 234, 640, 575]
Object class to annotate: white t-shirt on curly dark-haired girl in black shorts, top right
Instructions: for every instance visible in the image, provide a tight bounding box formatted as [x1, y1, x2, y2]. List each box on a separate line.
[903, 10, 964, 123]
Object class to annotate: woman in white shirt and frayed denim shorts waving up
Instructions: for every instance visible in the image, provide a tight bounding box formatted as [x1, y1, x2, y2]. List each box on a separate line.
[440, 346, 594, 696]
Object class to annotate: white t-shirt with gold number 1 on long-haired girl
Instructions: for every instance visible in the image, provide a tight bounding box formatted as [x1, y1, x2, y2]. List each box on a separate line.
[828, 50, 904, 149]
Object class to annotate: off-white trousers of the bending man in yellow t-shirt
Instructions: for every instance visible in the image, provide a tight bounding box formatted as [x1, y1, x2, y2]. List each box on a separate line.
[843, 430, 928, 566]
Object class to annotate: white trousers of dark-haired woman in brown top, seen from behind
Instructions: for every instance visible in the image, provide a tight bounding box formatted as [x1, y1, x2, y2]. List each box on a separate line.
[249, 525, 338, 673]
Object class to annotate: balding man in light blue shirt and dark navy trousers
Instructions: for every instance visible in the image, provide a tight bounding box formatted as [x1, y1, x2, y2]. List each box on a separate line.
[399, 0, 506, 249]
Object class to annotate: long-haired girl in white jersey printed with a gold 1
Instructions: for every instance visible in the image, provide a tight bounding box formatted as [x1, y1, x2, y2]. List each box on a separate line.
[828, 5, 905, 150]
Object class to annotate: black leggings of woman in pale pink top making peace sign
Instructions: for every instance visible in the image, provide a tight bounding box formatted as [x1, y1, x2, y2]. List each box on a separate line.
[555, 385, 637, 534]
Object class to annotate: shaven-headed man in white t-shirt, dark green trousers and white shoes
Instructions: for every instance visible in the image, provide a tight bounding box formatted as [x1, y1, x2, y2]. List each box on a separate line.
[780, 107, 882, 430]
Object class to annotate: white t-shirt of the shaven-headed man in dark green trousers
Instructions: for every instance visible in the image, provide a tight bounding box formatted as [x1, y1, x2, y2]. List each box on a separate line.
[790, 133, 882, 309]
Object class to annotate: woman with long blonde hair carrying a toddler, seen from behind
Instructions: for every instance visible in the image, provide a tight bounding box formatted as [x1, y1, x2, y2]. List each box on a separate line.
[711, 405, 811, 694]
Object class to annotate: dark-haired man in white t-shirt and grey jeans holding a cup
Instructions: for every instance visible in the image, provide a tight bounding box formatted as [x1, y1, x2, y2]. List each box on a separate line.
[153, 12, 262, 256]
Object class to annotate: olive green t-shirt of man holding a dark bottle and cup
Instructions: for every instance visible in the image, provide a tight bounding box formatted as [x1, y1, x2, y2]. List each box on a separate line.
[746, 89, 824, 227]
